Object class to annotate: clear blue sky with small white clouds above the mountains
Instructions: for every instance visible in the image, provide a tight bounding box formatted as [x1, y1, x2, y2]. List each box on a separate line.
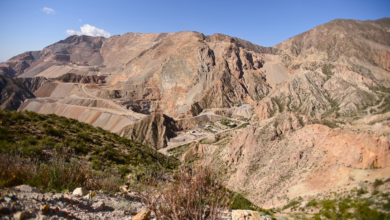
[0, 0, 390, 62]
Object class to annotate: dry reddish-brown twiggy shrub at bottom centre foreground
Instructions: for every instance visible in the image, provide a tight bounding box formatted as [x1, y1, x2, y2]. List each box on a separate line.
[140, 166, 230, 220]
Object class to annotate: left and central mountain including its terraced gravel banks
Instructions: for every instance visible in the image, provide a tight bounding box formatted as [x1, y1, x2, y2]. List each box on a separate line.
[4, 32, 284, 148]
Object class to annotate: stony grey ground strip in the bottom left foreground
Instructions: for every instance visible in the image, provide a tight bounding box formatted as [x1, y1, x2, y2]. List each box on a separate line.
[0, 185, 145, 219]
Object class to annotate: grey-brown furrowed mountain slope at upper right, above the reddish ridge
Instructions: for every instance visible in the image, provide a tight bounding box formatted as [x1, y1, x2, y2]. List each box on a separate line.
[255, 18, 390, 119]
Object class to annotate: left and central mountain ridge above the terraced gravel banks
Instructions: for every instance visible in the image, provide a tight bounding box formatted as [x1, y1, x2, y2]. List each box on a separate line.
[1, 32, 277, 117]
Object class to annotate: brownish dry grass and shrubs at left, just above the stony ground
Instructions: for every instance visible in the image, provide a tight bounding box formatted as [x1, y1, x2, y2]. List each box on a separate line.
[0, 152, 120, 192]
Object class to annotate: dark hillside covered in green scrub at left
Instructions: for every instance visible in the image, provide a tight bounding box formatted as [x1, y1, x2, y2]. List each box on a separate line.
[0, 110, 179, 192]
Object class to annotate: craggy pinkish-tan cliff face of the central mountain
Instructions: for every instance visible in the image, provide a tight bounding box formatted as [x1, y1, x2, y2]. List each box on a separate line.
[96, 32, 273, 117]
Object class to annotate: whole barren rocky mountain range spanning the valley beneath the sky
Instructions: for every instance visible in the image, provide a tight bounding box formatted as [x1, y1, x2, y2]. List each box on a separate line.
[0, 18, 390, 214]
